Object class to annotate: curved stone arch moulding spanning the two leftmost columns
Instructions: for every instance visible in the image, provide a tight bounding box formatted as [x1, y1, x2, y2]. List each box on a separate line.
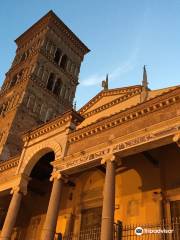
[18, 141, 62, 176]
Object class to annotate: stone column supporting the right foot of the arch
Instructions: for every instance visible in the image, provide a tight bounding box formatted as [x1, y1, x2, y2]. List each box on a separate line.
[41, 172, 63, 240]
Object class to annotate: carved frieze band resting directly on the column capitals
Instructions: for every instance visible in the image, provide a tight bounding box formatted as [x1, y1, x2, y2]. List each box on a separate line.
[57, 124, 180, 173]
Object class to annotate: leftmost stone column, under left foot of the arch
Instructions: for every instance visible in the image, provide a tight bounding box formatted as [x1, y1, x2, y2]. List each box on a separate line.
[0, 187, 23, 240]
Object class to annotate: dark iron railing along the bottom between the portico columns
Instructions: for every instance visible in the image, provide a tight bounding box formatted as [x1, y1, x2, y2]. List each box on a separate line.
[55, 217, 180, 240]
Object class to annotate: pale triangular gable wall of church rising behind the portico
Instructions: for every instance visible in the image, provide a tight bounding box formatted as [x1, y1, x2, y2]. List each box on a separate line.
[77, 85, 180, 129]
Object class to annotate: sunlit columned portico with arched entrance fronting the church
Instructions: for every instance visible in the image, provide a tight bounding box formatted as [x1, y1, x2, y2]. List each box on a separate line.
[0, 83, 180, 240]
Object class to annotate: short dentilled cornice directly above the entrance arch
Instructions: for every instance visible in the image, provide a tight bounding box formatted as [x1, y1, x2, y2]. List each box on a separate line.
[22, 109, 84, 142]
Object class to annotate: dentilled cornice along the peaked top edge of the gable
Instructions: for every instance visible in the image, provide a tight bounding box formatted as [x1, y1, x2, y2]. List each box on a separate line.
[78, 85, 142, 115]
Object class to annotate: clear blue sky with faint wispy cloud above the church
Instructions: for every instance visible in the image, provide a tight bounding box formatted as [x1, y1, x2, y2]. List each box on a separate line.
[0, 0, 180, 108]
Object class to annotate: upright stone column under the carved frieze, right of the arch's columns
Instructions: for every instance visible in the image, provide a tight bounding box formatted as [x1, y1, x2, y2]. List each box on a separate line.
[101, 154, 115, 240]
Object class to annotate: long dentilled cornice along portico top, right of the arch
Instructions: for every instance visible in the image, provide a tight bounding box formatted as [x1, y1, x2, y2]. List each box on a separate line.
[68, 87, 180, 144]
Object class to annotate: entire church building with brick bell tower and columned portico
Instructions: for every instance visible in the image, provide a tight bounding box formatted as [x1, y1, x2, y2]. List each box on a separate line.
[0, 11, 180, 240]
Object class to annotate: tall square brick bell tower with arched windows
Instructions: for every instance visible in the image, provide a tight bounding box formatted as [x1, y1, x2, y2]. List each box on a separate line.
[0, 11, 89, 160]
